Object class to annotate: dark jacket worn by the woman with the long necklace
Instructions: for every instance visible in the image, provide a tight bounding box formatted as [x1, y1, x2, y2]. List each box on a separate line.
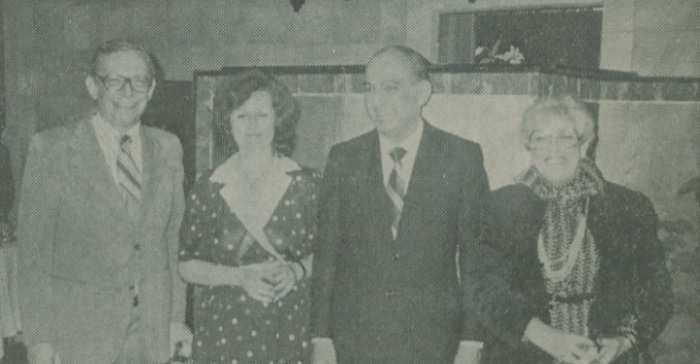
[477, 181, 673, 364]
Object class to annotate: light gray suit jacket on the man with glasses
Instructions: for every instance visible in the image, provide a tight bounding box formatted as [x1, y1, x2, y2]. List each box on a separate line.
[17, 118, 185, 364]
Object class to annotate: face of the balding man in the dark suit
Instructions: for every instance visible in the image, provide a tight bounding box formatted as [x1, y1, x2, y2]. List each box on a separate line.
[365, 52, 431, 141]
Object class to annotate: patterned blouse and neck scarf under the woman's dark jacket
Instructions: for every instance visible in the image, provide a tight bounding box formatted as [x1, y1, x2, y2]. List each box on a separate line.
[516, 159, 603, 362]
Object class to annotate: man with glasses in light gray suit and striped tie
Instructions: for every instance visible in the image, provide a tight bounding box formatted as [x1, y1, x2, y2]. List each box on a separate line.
[18, 40, 188, 364]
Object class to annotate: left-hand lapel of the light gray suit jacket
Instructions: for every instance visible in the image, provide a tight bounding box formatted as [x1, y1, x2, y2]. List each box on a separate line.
[70, 118, 125, 215]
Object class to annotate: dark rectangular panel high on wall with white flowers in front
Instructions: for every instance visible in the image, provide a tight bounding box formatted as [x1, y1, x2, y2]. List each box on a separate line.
[438, 6, 603, 69]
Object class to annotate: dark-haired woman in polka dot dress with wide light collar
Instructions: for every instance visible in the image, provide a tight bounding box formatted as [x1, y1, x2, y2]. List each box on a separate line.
[179, 71, 320, 364]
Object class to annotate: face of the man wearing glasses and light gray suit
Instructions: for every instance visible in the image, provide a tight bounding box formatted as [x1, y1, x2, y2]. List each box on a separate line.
[85, 50, 155, 131]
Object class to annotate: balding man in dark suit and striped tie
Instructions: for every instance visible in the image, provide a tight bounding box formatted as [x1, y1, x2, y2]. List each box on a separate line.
[312, 46, 488, 364]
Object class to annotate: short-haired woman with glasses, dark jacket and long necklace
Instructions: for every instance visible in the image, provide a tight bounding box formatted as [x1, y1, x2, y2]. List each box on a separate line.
[476, 97, 672, 364]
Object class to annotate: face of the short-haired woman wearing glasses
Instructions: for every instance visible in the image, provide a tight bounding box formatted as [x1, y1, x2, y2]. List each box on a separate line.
[527, 117, 588, 184]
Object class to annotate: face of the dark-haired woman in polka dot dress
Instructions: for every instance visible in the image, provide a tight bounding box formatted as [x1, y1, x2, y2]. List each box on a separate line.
[230, 90, 276, 153]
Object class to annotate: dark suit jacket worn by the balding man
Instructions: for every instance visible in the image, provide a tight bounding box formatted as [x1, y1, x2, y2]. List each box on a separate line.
[312, 123, 488, 364]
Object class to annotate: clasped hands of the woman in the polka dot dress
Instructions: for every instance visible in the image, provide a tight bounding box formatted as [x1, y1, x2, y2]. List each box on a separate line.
[237, 261, 303, 304]
